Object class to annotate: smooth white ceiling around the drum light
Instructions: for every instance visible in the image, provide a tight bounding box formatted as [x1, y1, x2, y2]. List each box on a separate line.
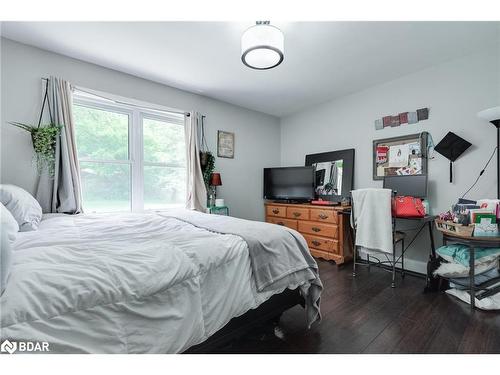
[2, 22, 500, 116]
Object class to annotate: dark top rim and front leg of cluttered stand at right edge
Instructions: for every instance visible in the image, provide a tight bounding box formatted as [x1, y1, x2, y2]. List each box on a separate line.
[442, 232, 500, 310]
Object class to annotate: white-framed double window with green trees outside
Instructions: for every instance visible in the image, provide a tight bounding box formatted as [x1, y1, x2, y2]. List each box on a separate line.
[73, 92, 186, 212]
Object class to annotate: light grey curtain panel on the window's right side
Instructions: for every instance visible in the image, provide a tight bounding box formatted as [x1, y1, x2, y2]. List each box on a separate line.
[184, 112, 207, 212]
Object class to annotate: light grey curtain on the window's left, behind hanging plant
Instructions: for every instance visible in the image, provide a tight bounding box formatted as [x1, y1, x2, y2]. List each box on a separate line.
[36, 77, 82, 214]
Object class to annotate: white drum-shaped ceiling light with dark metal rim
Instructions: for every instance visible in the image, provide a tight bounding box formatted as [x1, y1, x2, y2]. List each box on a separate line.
[241, 21, 285, 70]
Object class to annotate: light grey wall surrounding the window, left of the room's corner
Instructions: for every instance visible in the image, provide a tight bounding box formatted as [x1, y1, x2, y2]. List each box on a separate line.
[0, 38, 280, 220]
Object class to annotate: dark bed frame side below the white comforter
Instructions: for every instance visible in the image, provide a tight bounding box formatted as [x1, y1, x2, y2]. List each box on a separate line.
[184, 288, 304, 354]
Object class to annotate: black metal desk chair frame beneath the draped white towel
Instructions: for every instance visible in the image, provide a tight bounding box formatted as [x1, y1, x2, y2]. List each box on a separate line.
[351, 191, 406, 288]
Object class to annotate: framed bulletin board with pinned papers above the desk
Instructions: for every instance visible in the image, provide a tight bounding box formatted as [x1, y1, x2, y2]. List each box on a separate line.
[373, 132, 428, 180]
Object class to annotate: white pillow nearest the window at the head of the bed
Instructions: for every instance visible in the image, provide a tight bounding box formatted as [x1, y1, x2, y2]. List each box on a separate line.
[0, 185, 42, 232]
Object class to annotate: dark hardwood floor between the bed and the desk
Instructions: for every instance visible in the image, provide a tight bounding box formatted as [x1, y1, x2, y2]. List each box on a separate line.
[217, 261, 500, 353]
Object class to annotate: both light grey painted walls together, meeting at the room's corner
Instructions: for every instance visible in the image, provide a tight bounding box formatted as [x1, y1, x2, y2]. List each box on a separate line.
[1, 39, 500, 271]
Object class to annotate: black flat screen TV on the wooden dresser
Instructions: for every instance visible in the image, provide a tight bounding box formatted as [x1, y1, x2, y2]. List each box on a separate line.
[264, 167, 314, 202]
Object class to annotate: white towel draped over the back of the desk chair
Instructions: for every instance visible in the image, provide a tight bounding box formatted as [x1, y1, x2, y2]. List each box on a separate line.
[351, 189, 393, 254]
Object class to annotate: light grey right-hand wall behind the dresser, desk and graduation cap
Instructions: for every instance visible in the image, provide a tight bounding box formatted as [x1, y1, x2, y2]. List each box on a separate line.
[281, 50, 500, 271]
